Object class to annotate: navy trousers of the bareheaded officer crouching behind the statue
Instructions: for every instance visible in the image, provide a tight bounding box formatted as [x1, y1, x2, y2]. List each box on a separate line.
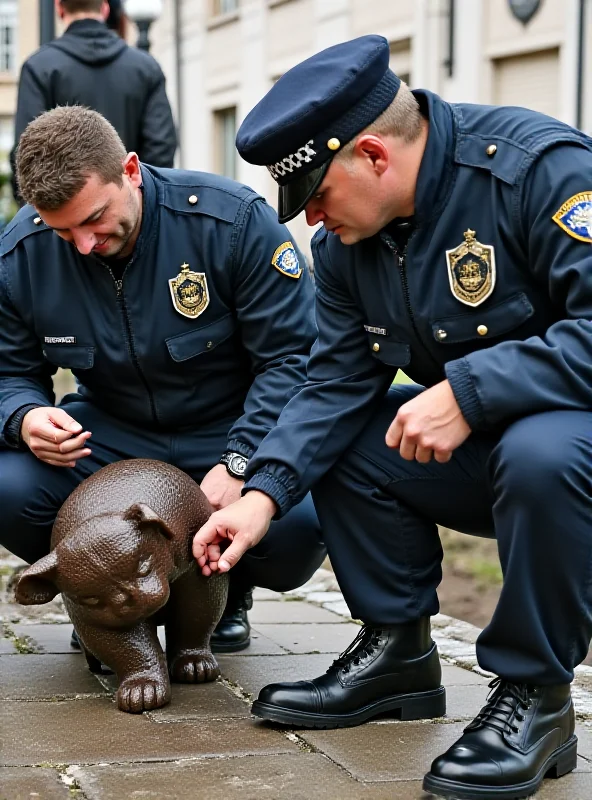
[0, 395, 326, 591]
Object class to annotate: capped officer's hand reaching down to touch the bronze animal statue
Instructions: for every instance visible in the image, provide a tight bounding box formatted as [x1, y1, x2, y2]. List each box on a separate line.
[193, 491, 277, 575]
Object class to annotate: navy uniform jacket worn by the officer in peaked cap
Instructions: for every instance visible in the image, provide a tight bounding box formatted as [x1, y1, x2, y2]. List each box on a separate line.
[246, 92, 592, 513]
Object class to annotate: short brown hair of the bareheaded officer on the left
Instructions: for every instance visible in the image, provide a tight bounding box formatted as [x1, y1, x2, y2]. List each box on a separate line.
[16, 106, 126, 211]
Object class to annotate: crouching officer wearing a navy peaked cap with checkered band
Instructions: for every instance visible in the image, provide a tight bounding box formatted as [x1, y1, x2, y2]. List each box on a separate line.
[194, 36, 592, 800]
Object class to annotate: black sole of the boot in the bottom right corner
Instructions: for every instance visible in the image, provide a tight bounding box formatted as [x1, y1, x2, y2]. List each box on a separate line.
[423, 736, 578, 800]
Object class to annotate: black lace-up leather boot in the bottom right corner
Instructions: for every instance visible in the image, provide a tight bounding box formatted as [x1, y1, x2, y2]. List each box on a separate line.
[423, 678, 578, 800]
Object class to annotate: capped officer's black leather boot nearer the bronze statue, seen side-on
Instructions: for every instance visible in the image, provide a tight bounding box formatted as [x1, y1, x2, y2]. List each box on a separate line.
[251, 617, 446, 728]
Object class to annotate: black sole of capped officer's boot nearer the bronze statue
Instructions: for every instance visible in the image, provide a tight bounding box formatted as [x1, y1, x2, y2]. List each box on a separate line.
[251, 686, 446, 728]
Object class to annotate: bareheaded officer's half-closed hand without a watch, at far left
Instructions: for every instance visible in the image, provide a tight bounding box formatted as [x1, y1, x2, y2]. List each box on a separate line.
[21, 406, 91, 467]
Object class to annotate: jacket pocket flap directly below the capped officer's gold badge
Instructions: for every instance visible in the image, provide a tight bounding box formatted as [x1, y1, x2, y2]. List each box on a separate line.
[432, 292, 534, 344]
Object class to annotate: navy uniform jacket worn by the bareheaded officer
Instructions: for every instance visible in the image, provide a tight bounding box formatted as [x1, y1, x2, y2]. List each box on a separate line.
[0, 166, 315, 456]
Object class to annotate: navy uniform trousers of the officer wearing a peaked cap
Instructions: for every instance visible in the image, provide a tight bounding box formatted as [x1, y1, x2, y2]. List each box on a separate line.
[313, 385, 592, 685]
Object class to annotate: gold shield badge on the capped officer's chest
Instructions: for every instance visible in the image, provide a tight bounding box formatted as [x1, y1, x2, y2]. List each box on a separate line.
[446, 229, 495, 306]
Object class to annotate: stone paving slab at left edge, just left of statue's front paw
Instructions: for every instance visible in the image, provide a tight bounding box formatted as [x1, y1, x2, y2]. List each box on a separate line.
[0, 654, 105, 700]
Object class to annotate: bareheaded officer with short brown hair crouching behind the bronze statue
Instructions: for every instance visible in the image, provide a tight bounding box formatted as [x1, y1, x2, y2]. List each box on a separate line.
[0, 106, 325, 652]
